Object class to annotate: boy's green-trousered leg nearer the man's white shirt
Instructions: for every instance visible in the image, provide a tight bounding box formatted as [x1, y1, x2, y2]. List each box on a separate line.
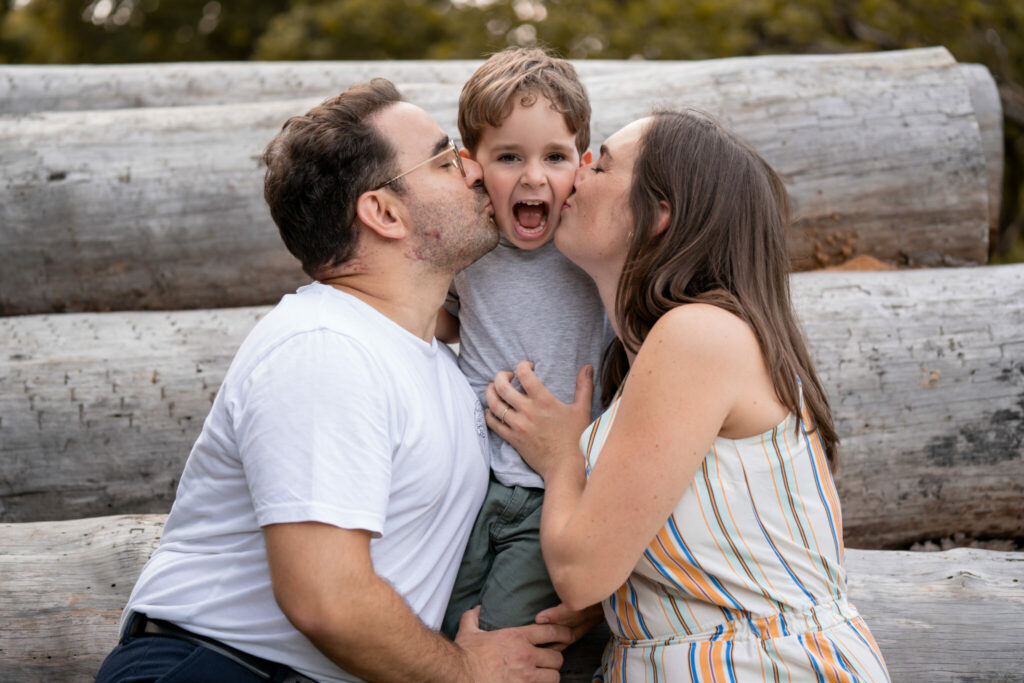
[441, 479, 512, 640]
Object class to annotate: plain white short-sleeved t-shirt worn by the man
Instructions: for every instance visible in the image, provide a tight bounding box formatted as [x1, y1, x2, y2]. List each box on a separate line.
[122, 283, 488, 681]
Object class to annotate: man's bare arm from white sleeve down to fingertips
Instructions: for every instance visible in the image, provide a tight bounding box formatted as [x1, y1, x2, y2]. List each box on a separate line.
[263, 522, 571, 683]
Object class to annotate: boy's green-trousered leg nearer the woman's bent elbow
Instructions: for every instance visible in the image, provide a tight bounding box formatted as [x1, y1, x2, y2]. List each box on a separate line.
[480, 486, 560, 631]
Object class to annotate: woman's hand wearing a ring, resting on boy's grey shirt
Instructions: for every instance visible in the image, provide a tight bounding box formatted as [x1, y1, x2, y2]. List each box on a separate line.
[485, 360, 594, 480]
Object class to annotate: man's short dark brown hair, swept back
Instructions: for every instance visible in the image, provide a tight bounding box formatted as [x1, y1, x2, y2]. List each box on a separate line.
[263, 78, 402, 279]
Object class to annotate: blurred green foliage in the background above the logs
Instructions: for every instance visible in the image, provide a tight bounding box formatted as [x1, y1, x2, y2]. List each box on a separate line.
[0, 0, 1024, 259]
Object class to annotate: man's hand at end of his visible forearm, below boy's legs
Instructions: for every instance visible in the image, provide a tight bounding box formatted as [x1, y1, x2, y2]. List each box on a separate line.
[455, 607, 572, 683]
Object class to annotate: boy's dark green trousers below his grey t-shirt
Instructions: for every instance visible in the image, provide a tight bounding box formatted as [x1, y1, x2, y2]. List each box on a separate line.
[441, 478, 560, 638]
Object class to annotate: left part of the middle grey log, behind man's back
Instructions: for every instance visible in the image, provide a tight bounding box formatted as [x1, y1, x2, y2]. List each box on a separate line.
[0, 308, 266, 521]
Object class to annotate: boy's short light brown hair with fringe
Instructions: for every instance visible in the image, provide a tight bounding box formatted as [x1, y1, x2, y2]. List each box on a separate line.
[459, 47, 590, 155]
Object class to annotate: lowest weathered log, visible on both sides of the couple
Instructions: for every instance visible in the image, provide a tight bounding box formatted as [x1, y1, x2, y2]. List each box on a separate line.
[0, 515, 1024, 683]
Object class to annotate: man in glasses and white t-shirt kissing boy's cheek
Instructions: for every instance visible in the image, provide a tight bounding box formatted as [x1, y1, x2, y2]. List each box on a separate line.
[97, 79, 572, 683]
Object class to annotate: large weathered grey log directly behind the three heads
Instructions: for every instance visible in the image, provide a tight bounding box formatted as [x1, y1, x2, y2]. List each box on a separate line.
[0, 48, 1001, 314]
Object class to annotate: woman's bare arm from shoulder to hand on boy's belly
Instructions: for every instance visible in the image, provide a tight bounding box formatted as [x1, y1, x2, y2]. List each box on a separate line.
[487, 304, 761, 608]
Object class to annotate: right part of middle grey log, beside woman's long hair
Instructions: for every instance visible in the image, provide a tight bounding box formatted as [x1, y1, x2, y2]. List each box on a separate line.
[793, 265, 1024, 548]
